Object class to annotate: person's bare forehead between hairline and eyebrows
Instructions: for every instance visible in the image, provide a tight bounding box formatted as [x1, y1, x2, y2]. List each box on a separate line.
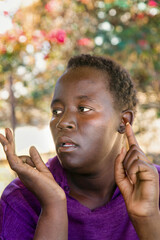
[51, 67, 114, 107]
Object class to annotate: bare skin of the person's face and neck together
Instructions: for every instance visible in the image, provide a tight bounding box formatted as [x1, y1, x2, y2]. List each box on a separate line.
[50, 68, 122, 209]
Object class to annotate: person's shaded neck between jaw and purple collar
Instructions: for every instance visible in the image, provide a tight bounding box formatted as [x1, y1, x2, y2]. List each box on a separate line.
[67, 145, 120, 209]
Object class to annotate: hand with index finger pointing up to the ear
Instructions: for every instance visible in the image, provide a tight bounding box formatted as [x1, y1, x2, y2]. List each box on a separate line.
[115, 124, 159, 218]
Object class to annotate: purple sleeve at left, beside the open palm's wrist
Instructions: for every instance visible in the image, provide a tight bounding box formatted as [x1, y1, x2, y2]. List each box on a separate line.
[0, 180, 40, 240]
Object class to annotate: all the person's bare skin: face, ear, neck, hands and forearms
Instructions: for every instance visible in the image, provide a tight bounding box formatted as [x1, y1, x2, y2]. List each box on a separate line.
[0, 67, 160, 240]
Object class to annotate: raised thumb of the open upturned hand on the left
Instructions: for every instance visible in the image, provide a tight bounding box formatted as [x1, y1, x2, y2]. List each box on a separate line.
[29, 146, 49, 172]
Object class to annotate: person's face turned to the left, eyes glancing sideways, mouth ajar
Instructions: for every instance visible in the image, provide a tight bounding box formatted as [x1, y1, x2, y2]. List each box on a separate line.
[50, 67, 119, 173]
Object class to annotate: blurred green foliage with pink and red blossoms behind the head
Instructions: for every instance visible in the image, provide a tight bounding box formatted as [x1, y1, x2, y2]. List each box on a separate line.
[0, 0, 160, 124]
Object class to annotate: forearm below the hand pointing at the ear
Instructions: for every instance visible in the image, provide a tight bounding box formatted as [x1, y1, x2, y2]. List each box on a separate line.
[131, 213, 160, 240]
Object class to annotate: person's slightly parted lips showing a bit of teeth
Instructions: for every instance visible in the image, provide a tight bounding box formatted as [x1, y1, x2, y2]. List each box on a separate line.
[57, 137, 78, 153]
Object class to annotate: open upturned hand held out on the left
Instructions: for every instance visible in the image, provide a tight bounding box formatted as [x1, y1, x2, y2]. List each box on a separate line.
[0, 128, 66, 207]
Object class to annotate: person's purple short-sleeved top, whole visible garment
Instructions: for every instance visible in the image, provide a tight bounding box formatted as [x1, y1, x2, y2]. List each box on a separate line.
[0, 157, 160, 240]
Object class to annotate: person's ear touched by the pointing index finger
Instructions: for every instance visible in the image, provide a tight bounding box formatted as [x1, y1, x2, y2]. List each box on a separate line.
[118, 110, 134, 134]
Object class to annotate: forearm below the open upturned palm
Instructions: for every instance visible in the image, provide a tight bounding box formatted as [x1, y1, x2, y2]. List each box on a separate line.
[33, 203, 68, 240]
